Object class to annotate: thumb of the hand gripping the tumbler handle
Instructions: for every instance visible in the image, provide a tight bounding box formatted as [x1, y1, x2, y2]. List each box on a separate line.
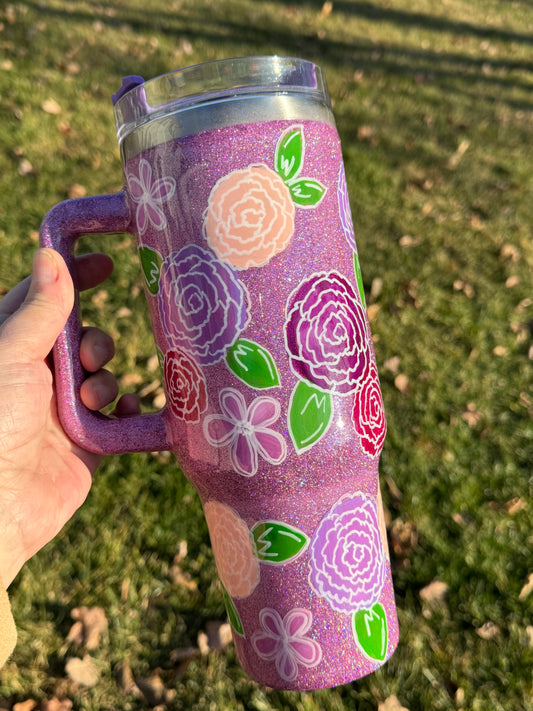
[2, 249, 74, 361]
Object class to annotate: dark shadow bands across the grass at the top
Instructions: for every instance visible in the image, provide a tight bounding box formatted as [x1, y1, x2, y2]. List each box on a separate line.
[16, 0, 533, 109]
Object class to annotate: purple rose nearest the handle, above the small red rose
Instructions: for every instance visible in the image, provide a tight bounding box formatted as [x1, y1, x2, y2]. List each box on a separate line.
[158, 244, 248, 365]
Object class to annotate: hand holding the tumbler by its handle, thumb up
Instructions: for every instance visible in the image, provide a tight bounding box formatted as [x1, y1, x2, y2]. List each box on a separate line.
[0, 249, 139, 587]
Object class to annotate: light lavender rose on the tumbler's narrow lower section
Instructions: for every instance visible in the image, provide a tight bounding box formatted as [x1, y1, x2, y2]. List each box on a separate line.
[310, 493, 385, 614]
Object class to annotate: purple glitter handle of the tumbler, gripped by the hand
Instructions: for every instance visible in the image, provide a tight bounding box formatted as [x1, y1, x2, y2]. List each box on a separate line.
[40, 191, 171, 454]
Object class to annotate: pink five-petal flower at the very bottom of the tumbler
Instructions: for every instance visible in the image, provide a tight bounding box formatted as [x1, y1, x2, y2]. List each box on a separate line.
[252, 607, 322, 681]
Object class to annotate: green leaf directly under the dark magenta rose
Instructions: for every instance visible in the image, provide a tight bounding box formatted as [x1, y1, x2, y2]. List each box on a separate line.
[289, 380, 333, 454]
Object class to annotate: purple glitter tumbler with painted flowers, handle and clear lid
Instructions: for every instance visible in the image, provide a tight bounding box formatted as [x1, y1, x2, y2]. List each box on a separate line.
[41, 57, 398, 689]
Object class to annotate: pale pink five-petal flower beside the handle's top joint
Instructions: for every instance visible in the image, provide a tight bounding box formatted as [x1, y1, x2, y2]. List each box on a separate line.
[126, 158, 176, 235]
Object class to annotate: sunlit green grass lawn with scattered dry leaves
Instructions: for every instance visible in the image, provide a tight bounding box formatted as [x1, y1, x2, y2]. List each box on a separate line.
[0, 0, 533, 711]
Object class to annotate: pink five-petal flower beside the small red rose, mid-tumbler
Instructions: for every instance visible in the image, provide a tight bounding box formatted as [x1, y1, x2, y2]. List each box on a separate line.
[203, 388, 287, 477]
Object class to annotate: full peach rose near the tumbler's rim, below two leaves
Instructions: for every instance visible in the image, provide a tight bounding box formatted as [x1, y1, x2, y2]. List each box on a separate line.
[204, 164, 295, 269]
